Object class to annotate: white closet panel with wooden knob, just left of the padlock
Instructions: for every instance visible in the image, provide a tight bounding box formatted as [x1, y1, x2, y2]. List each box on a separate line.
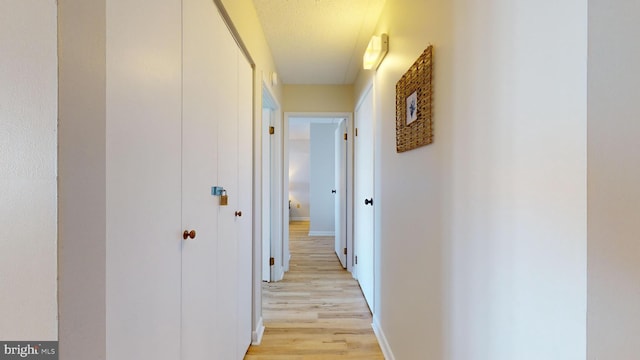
[181, 0, 220, 360]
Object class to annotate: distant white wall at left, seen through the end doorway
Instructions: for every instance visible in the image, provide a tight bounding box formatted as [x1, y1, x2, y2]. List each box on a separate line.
[289, 139, 311, 220]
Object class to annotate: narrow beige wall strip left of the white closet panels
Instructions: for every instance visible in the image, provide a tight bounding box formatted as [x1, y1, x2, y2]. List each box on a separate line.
[58, 0, 106, 360]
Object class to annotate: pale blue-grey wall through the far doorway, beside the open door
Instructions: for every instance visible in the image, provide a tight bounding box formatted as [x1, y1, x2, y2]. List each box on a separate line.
[309, 124, 337, 236]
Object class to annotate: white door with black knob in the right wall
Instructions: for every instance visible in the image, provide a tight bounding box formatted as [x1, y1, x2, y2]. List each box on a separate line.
[354, 89, 374, 309]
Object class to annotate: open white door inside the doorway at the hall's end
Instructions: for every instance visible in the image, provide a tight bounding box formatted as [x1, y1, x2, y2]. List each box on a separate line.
[334, 119, 347, 268]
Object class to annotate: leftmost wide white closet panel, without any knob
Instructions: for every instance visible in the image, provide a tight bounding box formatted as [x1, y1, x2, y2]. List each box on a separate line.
[104, 0, 182, 360]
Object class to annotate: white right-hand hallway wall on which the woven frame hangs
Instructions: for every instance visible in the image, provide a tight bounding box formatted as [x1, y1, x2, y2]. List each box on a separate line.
[356, 0, 587, 360]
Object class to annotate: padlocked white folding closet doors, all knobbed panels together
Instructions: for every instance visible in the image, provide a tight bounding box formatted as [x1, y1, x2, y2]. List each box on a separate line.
[181, 0, 253, 360]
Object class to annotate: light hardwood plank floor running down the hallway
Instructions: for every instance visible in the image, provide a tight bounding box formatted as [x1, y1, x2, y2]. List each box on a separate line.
[245, 222, 384, 360]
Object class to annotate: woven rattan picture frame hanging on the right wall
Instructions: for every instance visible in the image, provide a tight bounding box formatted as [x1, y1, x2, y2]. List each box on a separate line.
[396, 45, 433, 153]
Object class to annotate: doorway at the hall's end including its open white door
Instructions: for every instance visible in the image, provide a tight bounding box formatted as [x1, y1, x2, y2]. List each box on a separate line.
[283, 113, 353, 271]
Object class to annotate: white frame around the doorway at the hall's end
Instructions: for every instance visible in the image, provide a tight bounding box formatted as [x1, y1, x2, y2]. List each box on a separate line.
[282, 112, 353, 271]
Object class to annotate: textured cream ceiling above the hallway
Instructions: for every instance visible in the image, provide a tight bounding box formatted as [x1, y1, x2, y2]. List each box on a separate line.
[253, 0, 385, 84]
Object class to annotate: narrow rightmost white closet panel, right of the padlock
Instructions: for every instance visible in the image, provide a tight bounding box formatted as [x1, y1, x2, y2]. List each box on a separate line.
[236, 54, 253, 359]
